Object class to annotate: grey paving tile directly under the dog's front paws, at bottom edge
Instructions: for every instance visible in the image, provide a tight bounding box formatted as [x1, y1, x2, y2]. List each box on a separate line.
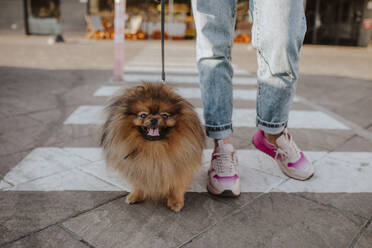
[63, 193, 233, 247]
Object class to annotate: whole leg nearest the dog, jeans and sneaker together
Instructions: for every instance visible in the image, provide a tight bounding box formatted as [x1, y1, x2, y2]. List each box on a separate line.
[192, 0, 240, 196]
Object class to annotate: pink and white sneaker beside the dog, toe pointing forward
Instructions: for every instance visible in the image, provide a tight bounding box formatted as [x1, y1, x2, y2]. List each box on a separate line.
[207, 140, 240, 197]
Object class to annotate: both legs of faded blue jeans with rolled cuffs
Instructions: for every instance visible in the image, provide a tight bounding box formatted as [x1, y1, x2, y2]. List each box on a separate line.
[192, 0, 306, 139]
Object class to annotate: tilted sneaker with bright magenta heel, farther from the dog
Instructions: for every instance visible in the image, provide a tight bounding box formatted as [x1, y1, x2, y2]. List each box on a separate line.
[253, 129, 314, 180]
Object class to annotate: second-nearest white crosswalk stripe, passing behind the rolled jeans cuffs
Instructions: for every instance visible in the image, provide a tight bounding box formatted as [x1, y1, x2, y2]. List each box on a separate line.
[64, 105, 348, 129]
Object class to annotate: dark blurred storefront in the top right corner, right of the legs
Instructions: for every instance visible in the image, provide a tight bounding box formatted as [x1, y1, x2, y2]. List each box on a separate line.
[305, 0, 372, 46]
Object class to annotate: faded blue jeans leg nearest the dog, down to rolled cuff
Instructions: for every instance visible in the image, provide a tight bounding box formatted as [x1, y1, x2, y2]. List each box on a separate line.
[192, 0, 236, 139]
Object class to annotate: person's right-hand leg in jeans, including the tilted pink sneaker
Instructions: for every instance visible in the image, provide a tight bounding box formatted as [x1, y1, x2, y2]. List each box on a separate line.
[250, 0, 313, 180]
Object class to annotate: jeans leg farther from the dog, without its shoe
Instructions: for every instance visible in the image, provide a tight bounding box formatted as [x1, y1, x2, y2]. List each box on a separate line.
[250, 0, 306, 134]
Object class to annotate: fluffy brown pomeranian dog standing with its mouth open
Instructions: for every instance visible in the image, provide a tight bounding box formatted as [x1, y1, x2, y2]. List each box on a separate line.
[101, 83, 205, 211]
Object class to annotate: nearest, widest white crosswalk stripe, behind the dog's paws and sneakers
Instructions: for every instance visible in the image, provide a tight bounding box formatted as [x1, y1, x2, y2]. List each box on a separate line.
[0, 147, 372, 193]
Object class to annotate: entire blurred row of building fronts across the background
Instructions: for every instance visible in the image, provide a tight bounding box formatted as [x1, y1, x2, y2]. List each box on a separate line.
[0, 0, 372, 46]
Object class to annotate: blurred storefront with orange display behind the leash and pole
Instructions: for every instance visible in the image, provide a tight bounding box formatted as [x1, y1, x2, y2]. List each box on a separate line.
[86, 0, 251, 42]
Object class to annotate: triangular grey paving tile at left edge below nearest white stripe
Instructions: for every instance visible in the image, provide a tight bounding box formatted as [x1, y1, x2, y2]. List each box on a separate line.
[0, 191, 123, 244]
